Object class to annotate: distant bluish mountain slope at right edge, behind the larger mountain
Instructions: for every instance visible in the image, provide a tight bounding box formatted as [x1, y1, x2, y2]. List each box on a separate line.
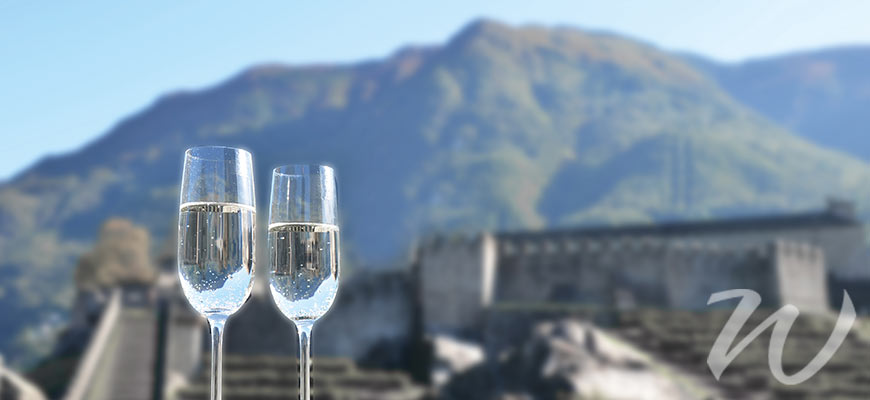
[691, 46, 870, 160]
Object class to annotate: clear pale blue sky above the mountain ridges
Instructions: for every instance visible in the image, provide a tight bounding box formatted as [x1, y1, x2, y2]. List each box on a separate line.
[0, 0, 870, 180]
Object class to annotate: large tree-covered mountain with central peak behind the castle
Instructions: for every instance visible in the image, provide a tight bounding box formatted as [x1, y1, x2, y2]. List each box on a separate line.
[0, 21, 870, 362]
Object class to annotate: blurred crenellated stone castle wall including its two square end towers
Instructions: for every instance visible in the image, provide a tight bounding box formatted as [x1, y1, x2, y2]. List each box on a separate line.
[418, 233, 828, 332]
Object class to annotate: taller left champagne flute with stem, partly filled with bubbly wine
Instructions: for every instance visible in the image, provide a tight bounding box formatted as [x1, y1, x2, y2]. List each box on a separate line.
[178, 146, 256, 400]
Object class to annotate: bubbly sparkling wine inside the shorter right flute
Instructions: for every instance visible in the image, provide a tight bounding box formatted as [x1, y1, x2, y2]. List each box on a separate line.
[269, 223, 339, 321]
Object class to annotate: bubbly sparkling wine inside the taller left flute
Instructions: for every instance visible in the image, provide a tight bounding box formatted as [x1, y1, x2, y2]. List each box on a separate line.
[178, 203, 256, 316]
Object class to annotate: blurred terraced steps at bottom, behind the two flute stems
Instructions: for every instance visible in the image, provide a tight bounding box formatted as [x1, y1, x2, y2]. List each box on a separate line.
[174, 354, 425, 400]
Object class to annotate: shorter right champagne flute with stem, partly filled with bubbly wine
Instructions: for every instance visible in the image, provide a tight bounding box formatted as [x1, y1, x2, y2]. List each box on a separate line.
[269, 165, 339, 400]
